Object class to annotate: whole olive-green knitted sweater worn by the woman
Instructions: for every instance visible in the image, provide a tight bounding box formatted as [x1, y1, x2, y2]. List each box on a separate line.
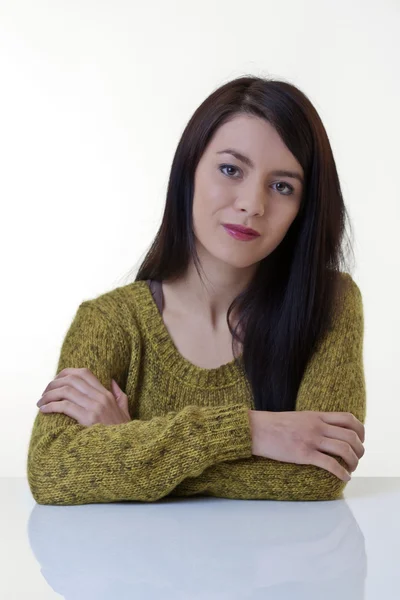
[27, 273, 366, 505]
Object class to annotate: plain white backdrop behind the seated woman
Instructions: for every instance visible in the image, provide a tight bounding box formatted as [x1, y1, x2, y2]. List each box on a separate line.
[0, 0, 400, 477]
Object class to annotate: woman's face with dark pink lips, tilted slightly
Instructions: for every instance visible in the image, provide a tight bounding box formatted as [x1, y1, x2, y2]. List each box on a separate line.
[193, 115, 304, 268]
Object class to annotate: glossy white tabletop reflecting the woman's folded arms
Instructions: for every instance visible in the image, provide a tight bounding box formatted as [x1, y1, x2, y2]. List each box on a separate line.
[0, 476, 400, 600]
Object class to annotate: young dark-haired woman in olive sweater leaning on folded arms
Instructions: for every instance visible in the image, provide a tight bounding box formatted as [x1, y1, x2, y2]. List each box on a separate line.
[27, 76, 366, 504]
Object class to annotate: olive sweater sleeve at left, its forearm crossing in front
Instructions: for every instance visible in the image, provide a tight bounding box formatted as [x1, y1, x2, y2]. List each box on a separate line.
[27, 300, 252, 505]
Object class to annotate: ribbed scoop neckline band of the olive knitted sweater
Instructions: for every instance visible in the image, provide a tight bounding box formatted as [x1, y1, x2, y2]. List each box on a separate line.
[134, 280, 243, 388]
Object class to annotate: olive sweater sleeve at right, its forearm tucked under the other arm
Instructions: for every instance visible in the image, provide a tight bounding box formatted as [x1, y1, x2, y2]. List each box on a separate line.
[171, 274, 366, 500]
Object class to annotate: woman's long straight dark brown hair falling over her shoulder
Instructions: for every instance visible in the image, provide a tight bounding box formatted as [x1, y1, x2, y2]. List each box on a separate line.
[121, 75, 353, 411]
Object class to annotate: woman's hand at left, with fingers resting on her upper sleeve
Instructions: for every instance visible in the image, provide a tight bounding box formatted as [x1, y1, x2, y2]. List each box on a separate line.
[37, 368, 132, 427]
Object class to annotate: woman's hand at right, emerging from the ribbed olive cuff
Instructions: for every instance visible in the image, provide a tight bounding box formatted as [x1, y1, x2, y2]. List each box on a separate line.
[249, 410, 365, 481]
